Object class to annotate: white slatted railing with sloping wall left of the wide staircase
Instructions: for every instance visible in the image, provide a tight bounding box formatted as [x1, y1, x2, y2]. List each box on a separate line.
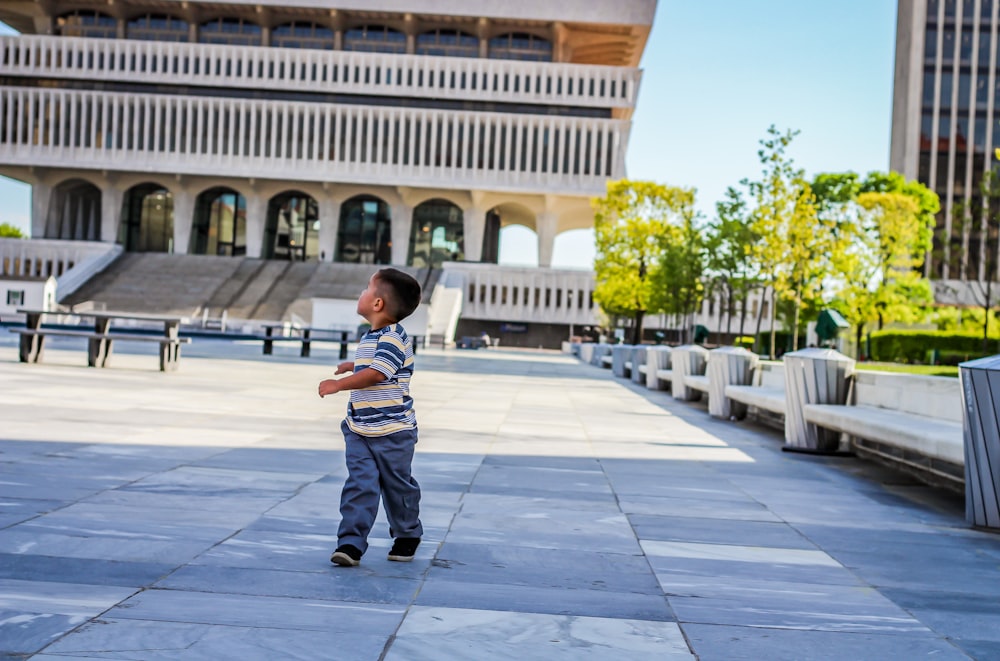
[0, 239, 122, 300]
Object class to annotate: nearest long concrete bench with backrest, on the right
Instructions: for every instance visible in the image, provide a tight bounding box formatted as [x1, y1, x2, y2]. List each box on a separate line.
[803, 371, 965, 484]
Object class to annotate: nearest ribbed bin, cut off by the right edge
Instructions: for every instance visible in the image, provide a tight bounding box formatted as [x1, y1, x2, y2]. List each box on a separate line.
[958, 355, 1000, 530]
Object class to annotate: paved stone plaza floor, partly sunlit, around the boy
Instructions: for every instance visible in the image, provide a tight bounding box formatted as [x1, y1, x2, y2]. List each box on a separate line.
[0, 333, 1000, 661]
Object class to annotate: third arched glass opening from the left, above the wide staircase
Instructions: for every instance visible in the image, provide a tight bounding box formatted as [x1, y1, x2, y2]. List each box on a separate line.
[189, 187, 247, 257]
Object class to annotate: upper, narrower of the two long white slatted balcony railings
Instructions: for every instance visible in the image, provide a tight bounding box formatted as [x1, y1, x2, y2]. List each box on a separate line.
[0, 36, 642, 108]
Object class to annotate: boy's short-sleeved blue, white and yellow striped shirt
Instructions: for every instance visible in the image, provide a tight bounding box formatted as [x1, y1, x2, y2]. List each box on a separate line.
[347, 324, 417, 436]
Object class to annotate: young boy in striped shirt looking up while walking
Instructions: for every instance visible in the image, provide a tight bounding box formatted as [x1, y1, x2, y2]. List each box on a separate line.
[319, 268, 423, 567]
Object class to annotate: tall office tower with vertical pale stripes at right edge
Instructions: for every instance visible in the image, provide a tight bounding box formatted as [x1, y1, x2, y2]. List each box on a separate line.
[889, 0, 1000, 280]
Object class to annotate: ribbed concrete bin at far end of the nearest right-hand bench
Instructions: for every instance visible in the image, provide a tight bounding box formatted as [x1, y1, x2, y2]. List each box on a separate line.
[782, 349, 854, 454]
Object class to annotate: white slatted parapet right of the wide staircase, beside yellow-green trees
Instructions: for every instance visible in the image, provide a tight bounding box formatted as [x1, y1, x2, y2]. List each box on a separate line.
[444, 262, 597, 325]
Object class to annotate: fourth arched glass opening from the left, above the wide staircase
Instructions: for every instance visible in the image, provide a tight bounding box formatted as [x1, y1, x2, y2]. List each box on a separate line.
[261, 191, 319, 262]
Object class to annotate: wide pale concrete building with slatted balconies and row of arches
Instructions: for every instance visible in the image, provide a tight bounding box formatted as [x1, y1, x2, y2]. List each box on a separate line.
[0, 0, 656, 346]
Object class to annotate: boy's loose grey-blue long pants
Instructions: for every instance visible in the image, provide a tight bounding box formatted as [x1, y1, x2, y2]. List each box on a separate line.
[337, 422, 424, 553]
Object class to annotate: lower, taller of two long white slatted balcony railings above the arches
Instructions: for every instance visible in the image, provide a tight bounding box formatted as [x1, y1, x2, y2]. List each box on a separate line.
[0, 87, 629, 195]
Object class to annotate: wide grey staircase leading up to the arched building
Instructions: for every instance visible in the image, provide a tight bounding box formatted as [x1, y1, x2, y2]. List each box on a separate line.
[60, 253, 440, 326]
